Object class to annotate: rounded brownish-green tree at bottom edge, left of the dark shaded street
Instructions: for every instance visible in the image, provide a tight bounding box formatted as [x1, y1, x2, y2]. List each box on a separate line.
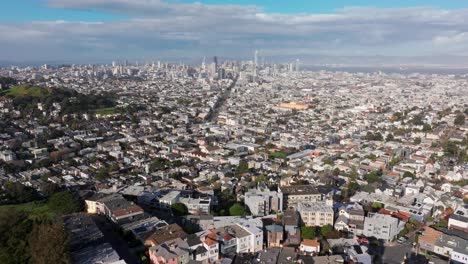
[28, 222, 71, 264]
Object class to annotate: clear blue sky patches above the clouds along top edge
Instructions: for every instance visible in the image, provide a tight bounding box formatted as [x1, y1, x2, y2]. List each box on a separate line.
[0, 0, 468, 22]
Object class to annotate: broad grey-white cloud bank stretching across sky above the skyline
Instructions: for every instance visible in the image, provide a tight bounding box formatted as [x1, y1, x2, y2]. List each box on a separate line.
[0, 0, 468, 59]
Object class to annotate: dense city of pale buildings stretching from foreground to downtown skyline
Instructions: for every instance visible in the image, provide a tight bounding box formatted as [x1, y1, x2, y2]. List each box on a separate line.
[0, 59, 468, 264]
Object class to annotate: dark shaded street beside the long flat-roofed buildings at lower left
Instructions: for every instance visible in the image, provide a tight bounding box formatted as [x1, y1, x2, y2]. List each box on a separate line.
[92, 215, 140, 264]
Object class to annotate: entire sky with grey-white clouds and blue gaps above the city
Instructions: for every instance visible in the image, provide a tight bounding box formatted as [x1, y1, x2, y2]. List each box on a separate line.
[0, 0, 468, 62]
